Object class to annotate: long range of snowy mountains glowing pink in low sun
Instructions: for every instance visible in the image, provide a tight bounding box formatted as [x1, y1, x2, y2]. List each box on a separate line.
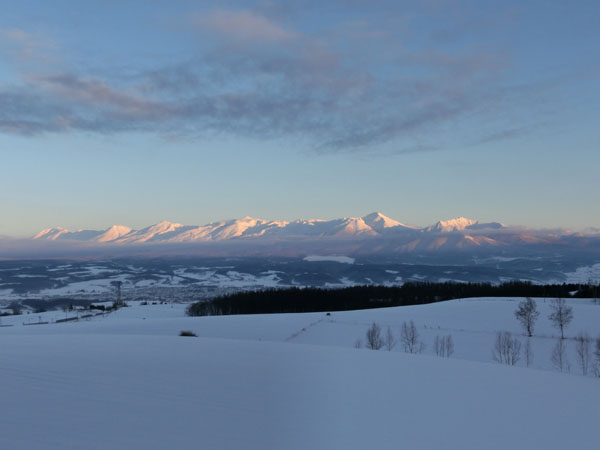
[33, 212, 596, 252]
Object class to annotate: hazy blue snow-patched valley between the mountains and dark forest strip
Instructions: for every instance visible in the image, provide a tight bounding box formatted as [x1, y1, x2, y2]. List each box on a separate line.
[0, 255, 600, 304]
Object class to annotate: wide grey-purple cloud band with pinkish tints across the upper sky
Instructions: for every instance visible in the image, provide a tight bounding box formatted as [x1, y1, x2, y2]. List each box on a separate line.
[0, 10, 516, 152]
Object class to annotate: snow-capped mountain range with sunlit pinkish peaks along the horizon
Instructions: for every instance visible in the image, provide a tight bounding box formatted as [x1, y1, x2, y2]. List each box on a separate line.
[20, 212, 599, 256]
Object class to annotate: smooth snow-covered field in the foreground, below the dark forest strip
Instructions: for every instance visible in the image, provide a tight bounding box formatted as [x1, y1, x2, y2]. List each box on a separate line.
[0, 299, 600, 450]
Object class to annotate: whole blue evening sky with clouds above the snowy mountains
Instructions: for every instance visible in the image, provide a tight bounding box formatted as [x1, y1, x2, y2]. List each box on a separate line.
[0, 0, 600, 237]
